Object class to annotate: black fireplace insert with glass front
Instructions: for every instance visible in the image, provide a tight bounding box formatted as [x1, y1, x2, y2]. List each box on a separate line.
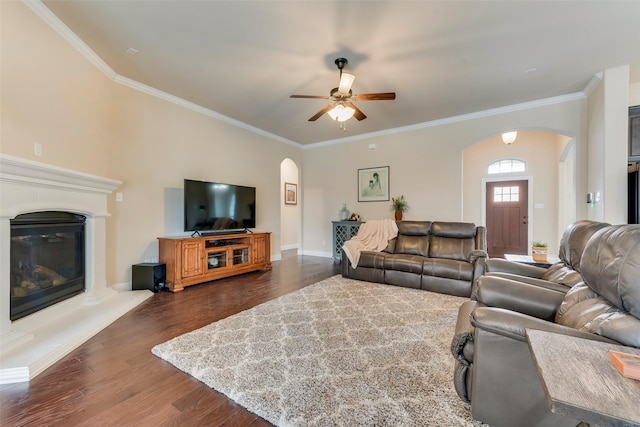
[10, 212, 86, 321]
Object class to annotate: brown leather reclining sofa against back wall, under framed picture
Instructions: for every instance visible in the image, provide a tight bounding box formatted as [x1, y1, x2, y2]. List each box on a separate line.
[342, 221, 487, 297]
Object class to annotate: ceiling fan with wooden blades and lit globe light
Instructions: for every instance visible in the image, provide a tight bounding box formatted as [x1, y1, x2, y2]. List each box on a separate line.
[291, 58, 396, 122]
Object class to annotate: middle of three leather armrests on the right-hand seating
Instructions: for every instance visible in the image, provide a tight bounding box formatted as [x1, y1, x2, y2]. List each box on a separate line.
[474, 276, 565, 322]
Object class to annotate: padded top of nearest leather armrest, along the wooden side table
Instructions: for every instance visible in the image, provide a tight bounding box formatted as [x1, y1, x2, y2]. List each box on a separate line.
[471, 306, 617, 344]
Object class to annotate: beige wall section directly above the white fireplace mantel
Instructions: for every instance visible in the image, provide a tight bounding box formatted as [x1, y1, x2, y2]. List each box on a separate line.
[0, 1, 113, 175]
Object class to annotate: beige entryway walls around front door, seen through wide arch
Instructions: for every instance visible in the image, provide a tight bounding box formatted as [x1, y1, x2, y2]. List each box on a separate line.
[463, 130, 576, 256]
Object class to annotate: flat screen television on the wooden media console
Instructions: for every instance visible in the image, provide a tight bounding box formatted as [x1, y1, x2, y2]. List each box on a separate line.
[184, 179, 256, 234]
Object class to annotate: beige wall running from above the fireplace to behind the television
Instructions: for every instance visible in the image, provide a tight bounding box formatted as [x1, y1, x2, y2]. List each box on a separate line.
[1, 2, 302, 284]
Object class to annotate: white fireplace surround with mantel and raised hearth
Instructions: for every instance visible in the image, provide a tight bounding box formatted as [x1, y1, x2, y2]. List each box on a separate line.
[0, 153, 153, 384]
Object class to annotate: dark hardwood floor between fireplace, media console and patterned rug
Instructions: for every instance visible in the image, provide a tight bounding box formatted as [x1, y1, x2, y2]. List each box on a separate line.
[0, 251, 340, 426]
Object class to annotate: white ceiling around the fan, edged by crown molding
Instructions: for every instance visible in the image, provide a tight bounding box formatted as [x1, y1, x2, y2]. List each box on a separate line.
[43, 0, 640, 145]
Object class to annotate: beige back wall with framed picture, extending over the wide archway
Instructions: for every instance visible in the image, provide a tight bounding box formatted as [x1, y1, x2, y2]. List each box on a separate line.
[303, 99, 586, 254]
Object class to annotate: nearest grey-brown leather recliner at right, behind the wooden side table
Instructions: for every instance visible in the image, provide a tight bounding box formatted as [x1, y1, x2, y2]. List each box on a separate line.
[451, 225, 640, 427]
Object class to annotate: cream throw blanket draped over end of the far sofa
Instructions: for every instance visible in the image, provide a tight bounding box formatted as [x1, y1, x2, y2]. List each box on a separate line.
[342, 219, 398, 268]
